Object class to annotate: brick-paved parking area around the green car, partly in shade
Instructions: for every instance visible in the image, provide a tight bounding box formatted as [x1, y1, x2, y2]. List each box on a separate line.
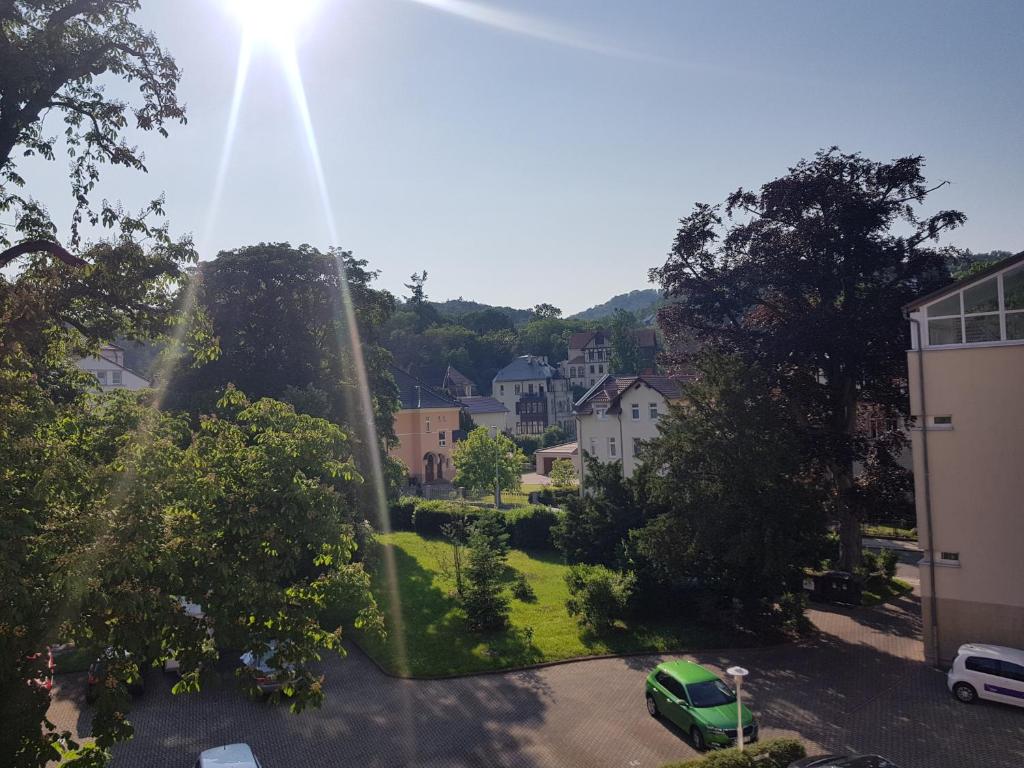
[50, 596, 1024, 768]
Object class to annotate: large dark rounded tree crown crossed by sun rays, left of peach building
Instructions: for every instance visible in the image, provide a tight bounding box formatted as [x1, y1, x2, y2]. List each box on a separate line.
[168, 243, 398, 444]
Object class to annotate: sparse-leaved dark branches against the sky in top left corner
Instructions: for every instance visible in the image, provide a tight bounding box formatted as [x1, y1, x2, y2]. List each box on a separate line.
[0, 0, 185, 266]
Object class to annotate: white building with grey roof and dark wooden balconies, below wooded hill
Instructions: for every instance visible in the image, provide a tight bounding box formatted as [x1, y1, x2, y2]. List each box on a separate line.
[492, 354, 575, 435]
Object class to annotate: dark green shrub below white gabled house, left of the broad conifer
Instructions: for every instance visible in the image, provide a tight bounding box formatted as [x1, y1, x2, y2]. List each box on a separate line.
[553, 454, 646, 565]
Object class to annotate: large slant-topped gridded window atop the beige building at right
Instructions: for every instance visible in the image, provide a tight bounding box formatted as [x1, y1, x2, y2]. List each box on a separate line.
[925, 265, 1024, 346]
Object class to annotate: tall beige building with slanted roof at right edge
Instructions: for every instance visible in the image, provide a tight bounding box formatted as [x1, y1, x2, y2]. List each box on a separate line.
[906, 253, 1024, 664]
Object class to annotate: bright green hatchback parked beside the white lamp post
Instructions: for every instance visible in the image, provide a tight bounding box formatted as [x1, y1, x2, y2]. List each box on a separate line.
[646, 662, 758, 752]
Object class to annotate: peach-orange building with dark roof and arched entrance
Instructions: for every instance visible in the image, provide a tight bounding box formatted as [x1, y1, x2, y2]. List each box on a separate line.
[388, 367, 462, 484]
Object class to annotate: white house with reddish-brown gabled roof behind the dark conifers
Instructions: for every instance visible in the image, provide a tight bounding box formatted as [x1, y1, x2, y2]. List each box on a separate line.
[575, 376, 682, 477]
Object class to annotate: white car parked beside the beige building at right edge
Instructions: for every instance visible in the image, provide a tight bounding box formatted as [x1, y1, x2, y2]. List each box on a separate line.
[946, 643, 1024, 707]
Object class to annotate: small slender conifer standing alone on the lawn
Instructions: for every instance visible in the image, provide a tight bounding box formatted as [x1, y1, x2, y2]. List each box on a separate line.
[463, 511, 509, 632]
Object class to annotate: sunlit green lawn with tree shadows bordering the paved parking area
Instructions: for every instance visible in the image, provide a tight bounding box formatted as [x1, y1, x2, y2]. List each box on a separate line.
[357, 531, 750, 677]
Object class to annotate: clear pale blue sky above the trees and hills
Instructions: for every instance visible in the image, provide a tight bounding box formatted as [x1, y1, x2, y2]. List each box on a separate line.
[22, 0, 1024, 313]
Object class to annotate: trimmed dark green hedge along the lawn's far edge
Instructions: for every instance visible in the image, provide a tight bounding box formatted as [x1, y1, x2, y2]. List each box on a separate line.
[389, 497, 562, 550]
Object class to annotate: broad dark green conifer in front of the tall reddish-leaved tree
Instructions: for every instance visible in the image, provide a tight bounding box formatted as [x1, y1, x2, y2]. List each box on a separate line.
[629, 354, 824, 624]
